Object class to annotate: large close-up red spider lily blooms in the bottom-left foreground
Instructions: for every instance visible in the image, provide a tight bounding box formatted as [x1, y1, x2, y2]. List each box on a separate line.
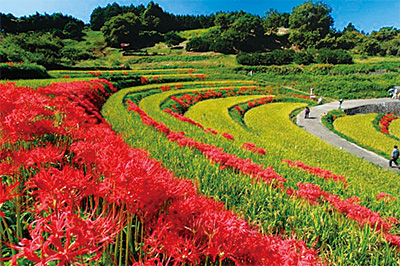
[13, 209, 121, 265]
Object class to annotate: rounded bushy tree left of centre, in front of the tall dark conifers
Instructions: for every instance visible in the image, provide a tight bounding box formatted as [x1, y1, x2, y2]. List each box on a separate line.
[101, 13, 142, 47]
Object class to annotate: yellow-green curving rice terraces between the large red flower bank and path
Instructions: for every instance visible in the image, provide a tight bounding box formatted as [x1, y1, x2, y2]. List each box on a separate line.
[103, 68, 399, 265]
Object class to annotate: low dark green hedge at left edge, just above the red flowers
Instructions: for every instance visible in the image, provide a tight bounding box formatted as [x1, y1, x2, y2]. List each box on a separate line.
[0, 62, 50, 79]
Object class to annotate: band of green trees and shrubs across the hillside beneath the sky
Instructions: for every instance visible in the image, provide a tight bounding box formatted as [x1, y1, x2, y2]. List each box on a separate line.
[0, 1, 400, 69]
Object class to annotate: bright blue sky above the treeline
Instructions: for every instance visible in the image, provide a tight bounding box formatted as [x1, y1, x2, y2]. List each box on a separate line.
[0, 0, 400, 33]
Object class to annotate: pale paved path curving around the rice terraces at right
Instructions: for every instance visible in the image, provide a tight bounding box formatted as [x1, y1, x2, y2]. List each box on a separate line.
[297, 98, 399, 168]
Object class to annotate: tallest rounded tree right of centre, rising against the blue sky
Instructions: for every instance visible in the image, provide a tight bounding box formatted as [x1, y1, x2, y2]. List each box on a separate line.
[289, 1, 333, 48]
